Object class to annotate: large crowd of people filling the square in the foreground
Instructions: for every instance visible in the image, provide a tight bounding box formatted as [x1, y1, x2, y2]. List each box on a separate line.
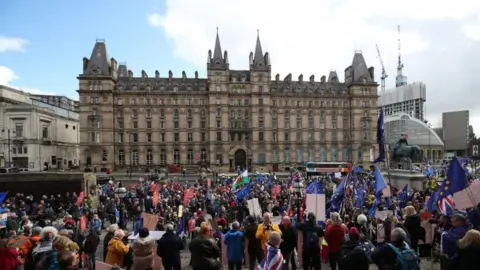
[0, 165, 480, 270]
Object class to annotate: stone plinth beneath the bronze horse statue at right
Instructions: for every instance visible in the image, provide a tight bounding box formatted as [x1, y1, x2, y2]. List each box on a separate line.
[382, 169, 425, 190]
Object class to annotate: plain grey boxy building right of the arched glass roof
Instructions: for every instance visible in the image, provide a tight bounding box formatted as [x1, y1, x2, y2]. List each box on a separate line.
[442, 111, 470, 156]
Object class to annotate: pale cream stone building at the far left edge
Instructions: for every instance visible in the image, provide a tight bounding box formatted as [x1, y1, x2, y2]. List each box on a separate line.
[0, 86, 80, 171]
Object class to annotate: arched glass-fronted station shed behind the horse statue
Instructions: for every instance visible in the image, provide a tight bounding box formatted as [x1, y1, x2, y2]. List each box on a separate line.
[383, 113, 444, 163]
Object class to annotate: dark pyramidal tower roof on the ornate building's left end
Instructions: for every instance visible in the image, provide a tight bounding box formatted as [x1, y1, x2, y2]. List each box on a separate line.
[83, 39, 111, 76]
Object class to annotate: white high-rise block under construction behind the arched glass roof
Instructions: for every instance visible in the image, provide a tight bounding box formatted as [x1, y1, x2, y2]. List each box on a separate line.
[379, 81, 427, 121]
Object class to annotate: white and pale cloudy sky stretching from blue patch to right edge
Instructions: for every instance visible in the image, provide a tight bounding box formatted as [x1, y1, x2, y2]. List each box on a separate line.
[149, 0, 480, 133]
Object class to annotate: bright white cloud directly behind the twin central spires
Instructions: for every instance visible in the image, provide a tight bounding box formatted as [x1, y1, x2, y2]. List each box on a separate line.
[148, 0, 432, 78]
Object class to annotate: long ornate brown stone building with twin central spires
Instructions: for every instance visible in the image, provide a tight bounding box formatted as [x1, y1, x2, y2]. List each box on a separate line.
[78, 34, 378, 171]
